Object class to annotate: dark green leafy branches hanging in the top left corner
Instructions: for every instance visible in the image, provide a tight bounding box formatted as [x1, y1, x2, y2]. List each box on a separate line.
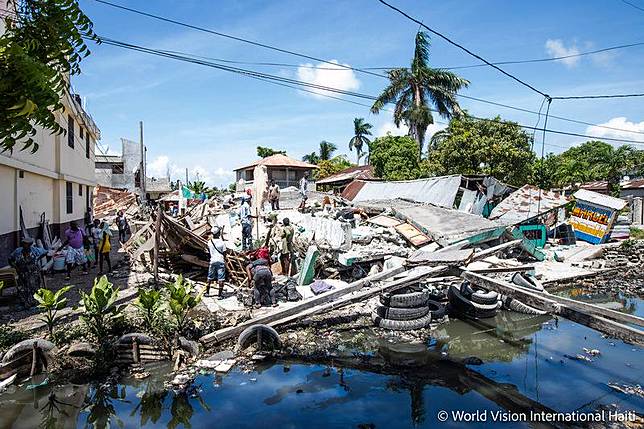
[0, 0, 98, 152]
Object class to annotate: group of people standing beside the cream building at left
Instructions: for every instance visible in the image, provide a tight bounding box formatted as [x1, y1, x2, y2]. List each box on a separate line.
[9, 211, 129, 308]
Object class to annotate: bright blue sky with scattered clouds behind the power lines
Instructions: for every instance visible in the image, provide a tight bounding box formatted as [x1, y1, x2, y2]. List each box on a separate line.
[73, 0, 644, 185]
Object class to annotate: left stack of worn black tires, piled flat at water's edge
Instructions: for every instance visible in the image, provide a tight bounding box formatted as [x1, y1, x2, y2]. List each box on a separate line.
[371, 290, 445, 331]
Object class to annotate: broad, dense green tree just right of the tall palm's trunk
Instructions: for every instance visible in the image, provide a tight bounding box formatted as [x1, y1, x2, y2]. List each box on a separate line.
[425, 116, 535, 186]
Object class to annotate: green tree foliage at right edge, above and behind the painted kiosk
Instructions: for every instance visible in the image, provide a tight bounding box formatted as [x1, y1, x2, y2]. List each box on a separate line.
[536, 140, 644, 192]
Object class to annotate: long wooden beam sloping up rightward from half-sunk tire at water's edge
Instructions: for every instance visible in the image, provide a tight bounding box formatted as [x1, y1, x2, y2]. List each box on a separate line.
[199, 267, 405, 347]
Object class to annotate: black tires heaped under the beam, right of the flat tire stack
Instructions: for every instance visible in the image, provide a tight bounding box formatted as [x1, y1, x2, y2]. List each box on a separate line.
[447, 281, 501, 319]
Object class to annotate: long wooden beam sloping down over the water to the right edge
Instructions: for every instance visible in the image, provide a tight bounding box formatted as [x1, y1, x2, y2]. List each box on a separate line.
[461, 271, 644, 345]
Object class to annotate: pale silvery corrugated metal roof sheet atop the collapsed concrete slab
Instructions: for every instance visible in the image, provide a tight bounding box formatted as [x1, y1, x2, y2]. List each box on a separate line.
[342, 175, 461, 208]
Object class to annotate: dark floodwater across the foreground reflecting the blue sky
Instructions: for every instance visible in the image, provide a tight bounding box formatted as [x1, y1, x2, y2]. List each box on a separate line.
[0, 300, 644, 429]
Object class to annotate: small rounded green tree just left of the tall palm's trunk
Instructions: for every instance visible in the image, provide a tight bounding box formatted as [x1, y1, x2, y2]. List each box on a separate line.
[369, 133, 420, 180]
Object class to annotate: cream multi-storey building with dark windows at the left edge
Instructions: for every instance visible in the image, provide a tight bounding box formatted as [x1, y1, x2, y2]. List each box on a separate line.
[0, 0, 100, 266]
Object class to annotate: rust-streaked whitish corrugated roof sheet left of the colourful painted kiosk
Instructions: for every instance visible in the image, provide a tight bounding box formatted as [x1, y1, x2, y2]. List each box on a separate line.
[489, 185, 570, 225]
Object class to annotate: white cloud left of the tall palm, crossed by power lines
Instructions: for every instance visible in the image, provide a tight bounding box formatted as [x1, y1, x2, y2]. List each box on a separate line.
[297, 60, 360, 97]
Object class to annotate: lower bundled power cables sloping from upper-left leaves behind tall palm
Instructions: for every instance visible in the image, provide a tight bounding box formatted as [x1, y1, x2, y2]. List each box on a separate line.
[89, 37, 644, 145]
